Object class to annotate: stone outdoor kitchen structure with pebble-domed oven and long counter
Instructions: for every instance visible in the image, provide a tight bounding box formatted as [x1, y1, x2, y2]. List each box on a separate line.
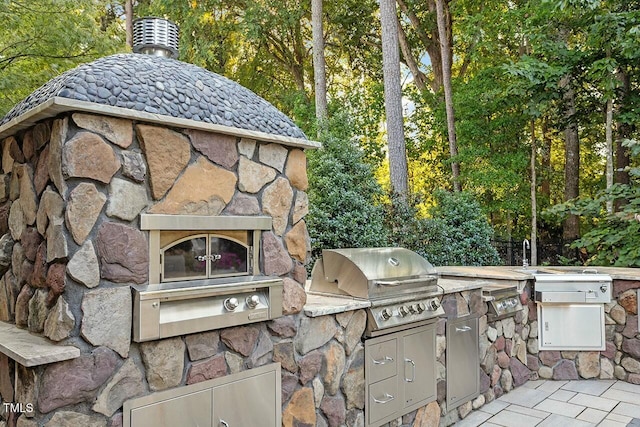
[0, 18, 640, 427]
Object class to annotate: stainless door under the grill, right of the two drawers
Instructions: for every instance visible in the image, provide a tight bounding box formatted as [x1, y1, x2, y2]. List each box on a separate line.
[400, 327, 436, 408]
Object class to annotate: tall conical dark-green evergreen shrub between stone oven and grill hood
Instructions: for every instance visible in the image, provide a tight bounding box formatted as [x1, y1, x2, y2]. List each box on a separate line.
[306, 115, 387, 266]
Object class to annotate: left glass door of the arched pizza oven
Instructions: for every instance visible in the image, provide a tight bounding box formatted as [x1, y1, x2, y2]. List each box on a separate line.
[162, 235, 207, 281]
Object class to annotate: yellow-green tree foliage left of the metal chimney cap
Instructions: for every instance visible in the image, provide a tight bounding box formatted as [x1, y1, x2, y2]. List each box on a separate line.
[0, 0, 125, 116]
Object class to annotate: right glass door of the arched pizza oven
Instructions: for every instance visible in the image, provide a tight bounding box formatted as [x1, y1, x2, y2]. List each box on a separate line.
[209, 235, 249, 277]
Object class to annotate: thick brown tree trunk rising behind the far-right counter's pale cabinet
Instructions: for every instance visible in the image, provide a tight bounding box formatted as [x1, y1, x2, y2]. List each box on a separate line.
[560, 75, 580, 246]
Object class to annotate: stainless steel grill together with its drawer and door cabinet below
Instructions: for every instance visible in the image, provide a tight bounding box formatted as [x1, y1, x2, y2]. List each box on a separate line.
[309, 248, 444, 427]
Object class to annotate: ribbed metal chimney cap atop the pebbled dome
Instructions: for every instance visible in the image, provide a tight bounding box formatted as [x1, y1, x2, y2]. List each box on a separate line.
[133, 17, 179, 59]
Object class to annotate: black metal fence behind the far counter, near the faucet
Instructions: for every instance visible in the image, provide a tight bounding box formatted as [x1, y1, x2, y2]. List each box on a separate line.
[491, 240, 580, 265]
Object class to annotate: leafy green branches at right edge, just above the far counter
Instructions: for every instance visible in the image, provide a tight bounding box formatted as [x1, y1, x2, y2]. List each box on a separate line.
[544, 140, 640, 267]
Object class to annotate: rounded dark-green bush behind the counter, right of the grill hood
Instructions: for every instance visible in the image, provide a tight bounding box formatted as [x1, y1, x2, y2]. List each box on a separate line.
[387, 191, 500, 265]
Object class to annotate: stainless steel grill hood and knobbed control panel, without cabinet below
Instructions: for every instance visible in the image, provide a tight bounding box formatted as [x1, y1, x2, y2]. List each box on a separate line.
[310, 248, 444, 336]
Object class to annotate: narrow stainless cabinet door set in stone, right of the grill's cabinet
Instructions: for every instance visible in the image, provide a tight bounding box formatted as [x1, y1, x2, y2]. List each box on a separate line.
[447, 317, 480, 410]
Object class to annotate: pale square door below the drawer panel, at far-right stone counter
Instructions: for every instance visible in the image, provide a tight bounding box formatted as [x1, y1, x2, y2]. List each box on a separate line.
[537, 303, 606, 351]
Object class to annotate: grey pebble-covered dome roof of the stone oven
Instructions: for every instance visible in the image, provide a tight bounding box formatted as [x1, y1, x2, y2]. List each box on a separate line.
[0, 54, 307, 139]
